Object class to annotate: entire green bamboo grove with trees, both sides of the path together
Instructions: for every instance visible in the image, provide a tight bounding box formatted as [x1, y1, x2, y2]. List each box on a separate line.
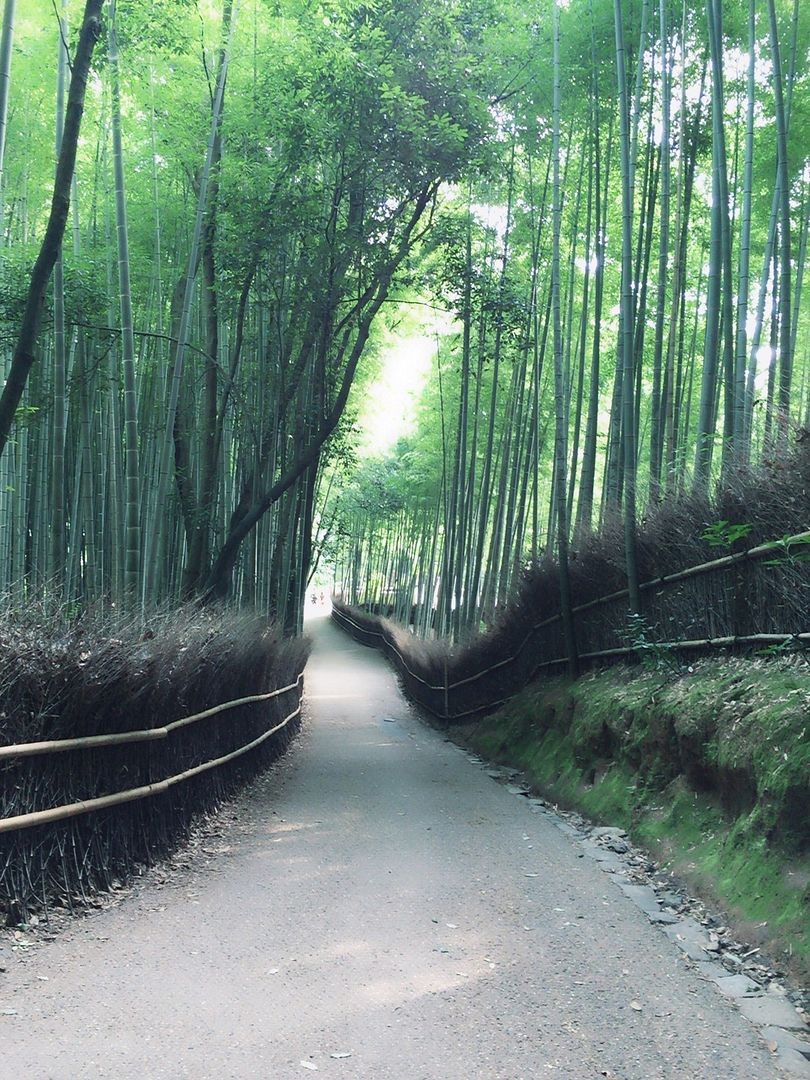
[0, 0, 810, 637]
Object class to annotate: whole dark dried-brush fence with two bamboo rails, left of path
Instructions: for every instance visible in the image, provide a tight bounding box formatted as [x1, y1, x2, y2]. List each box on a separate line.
[0, 608, 307, 923]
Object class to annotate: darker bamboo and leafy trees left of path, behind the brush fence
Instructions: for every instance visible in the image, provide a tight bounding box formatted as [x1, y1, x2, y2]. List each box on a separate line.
[0, 0, 501, 630]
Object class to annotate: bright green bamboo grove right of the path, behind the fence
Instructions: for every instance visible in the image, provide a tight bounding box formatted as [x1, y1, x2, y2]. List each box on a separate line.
[324, 0, 810, 639]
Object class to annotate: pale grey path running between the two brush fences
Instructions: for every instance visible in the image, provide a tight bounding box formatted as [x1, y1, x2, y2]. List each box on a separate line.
[0, 620, 794, 1080]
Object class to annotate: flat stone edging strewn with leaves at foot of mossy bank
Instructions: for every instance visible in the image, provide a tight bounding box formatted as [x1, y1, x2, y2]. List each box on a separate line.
[460, 740, 810, 1080]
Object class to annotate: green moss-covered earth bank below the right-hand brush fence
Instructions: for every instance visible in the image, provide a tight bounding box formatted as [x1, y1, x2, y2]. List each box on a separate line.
[451, 659, 810, 974]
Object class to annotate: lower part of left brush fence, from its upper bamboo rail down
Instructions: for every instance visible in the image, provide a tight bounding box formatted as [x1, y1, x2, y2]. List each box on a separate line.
[0, 672, 303, 923]
